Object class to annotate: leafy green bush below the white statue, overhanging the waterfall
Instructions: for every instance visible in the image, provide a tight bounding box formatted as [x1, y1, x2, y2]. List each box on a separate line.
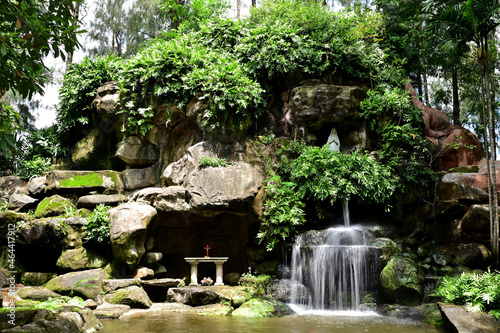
[258, 141, 398, 250]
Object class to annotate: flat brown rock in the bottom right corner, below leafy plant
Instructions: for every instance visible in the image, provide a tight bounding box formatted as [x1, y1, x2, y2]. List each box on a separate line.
[438, 303, 500, 333]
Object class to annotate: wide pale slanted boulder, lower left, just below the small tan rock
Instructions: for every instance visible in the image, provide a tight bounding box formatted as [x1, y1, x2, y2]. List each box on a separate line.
[45, 269, 107, 300]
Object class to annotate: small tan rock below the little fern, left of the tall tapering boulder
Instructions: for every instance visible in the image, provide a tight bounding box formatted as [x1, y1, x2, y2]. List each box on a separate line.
[56, 246, 108, 271]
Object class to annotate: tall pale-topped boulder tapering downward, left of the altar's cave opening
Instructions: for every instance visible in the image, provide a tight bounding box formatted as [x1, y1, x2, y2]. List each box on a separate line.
[109, 202, 156, 275]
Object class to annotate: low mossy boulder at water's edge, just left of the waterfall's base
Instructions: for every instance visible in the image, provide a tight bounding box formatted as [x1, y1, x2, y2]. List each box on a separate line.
[232, 298, 294, 318]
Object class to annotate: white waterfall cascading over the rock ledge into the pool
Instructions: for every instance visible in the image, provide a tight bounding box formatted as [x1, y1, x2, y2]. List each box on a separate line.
[291, 226, 380, 310]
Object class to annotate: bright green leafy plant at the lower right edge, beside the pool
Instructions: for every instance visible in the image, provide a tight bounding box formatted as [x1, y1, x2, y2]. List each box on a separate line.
[435, 270, 500, 319]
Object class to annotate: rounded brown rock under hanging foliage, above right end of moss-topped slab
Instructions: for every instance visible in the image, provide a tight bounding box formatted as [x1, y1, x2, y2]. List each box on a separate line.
[116, 136, 159, 167]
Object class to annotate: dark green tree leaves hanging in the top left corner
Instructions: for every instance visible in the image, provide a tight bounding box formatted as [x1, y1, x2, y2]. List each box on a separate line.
[0, 0, 82, 97]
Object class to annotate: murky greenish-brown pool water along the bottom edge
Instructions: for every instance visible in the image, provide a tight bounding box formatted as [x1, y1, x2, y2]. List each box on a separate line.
[100, 312, 446, 333]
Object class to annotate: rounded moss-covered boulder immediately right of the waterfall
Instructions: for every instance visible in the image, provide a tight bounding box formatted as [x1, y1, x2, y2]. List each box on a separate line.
[380, 256, 424, 306]
